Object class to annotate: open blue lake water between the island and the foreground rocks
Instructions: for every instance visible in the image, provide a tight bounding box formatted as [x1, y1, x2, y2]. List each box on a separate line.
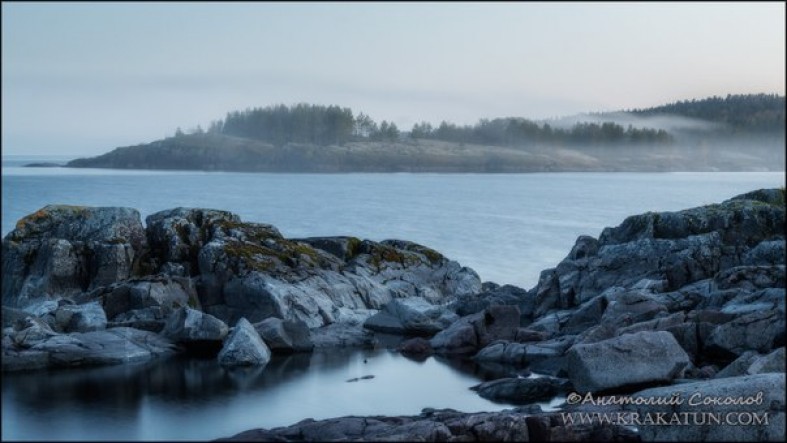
[2, 158, 785, 289]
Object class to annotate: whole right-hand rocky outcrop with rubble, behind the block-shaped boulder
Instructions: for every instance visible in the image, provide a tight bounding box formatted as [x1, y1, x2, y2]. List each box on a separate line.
[462, 189, 785, 376]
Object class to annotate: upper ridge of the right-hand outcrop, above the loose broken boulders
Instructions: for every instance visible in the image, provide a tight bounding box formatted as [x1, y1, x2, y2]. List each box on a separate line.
[534, 189, 785, 317]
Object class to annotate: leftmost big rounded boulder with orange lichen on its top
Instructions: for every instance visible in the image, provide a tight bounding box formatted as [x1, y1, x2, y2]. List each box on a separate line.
[2, 205, 146, 307]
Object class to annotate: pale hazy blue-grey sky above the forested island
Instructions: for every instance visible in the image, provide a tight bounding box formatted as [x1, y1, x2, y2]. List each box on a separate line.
[2, 1, 786, 155]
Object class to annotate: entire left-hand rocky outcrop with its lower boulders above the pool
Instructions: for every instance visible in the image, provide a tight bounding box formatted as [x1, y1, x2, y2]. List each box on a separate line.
[2, 206, 481, 367]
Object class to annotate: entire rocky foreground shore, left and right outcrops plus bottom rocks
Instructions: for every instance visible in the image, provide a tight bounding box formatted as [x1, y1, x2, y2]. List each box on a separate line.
[2, 189, 785, 441]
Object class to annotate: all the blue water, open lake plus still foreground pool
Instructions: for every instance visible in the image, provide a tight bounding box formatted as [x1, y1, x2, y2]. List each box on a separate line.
[2, 157, 785, 440]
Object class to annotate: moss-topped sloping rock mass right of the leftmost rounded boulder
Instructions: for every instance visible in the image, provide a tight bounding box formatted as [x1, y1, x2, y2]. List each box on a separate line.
[147, 208, 480, 328]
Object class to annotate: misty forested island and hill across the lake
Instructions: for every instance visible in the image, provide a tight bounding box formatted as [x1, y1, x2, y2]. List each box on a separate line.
[66, 94, 785, 172]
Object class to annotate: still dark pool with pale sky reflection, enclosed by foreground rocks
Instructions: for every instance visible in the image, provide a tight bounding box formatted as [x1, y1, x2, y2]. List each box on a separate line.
[2, 349, 506, 440]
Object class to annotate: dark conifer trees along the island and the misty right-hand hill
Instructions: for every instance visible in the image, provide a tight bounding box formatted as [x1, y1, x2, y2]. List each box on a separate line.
[176, 94, 785, 147]
